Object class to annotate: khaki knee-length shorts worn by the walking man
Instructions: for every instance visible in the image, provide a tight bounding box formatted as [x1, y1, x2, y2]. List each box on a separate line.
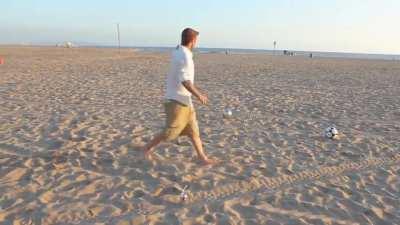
[163, 100, 200, 141]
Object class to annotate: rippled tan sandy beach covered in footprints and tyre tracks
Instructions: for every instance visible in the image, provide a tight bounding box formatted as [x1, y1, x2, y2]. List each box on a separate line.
[0, 46, 400, 225]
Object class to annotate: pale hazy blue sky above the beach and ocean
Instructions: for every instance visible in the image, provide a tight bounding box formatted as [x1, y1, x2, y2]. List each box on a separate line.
[0, 0, 400, 54]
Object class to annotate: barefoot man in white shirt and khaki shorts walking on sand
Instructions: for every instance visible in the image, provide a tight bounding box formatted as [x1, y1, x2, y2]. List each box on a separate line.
[144, 28, 215, 164]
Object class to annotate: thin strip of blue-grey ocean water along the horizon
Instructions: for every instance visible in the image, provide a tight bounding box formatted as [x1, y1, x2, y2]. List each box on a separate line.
[129, 47, 400, 61]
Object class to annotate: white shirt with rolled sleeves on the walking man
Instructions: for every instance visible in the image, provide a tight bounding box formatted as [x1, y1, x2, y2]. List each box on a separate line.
[165, 45, 194, 107]
